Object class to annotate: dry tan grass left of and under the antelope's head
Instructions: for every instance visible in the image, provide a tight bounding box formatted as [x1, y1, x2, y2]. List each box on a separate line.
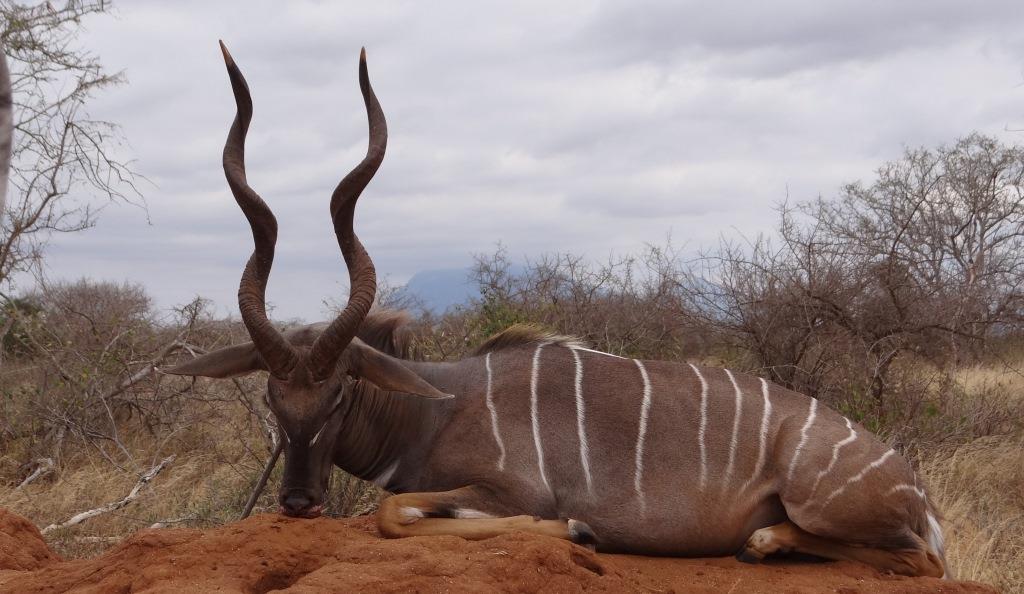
[0, 384, 383, 558]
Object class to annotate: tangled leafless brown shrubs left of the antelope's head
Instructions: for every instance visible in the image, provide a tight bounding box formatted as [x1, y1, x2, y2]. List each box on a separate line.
[0, 281, 272, 493]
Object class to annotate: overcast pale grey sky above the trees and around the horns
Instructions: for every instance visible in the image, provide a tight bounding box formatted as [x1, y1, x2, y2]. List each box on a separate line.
[32, 0, 1024, 319]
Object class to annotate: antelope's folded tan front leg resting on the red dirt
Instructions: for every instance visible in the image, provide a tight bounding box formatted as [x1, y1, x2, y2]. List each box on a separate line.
[377, 486, 595, 544]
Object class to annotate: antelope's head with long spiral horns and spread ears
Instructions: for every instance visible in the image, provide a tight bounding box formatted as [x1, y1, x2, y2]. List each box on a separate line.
[166, 43, 450, 517]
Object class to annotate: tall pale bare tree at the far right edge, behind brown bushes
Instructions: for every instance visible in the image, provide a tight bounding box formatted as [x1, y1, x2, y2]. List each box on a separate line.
[803, 134, 1024, 366]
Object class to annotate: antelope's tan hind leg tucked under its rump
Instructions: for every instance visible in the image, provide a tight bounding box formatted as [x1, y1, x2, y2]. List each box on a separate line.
[736, 521, 943, 578]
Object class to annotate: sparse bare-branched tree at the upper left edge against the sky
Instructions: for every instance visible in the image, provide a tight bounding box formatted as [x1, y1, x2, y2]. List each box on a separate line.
[0, 0, 141, 290]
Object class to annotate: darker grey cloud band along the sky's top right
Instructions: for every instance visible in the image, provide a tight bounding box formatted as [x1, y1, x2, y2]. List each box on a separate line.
[582, 0, 1020, 77]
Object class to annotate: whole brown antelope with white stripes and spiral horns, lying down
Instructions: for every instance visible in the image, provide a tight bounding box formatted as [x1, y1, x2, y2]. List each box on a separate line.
[167, 44, 947, 577]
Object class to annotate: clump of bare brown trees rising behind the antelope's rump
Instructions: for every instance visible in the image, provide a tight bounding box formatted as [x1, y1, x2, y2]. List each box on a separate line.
[683, 134, 1024, 438]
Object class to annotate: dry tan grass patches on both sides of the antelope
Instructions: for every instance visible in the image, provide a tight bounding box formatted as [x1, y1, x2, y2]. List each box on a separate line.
[0, 354, 1024, 594]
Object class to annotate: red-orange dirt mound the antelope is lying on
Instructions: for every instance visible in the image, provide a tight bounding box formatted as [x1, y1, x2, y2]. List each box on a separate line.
[0, 514, 994, 594]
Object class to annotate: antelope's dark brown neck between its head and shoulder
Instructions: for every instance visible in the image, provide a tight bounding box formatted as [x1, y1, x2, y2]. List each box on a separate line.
[334, 360, 451, 493]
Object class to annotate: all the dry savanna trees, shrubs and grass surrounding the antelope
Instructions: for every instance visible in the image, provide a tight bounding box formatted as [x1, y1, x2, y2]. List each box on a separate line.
[0, 2, 1024, 592]
